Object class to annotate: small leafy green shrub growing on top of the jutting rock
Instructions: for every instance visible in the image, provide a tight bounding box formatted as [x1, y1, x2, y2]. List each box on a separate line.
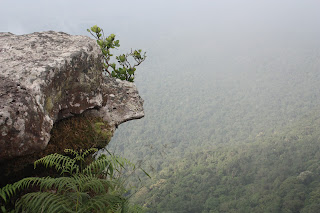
[87, 25, 146, 82]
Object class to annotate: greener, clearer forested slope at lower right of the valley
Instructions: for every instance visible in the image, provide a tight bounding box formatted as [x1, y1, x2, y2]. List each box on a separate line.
[136, 110, 320, 213]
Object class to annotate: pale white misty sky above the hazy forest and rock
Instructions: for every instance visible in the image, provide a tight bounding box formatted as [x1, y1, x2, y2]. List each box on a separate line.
[0, 0, 320, 76]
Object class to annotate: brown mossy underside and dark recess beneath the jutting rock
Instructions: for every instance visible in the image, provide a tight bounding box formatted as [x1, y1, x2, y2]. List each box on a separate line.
[0, 115, 113, 187]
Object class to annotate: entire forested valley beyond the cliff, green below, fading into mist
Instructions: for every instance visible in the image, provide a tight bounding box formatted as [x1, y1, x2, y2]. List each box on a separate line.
[109, 44, 320, 213]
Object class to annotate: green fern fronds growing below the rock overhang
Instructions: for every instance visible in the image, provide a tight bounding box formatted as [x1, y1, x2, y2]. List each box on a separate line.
[0, 149, 146, 213]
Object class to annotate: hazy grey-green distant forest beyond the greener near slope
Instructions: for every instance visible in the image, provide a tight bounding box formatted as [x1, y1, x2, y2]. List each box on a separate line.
[110, 47, 320, 166]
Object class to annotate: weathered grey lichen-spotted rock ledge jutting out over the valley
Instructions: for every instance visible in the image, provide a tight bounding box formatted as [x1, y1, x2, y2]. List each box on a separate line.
[0, 31, 144, 161]
